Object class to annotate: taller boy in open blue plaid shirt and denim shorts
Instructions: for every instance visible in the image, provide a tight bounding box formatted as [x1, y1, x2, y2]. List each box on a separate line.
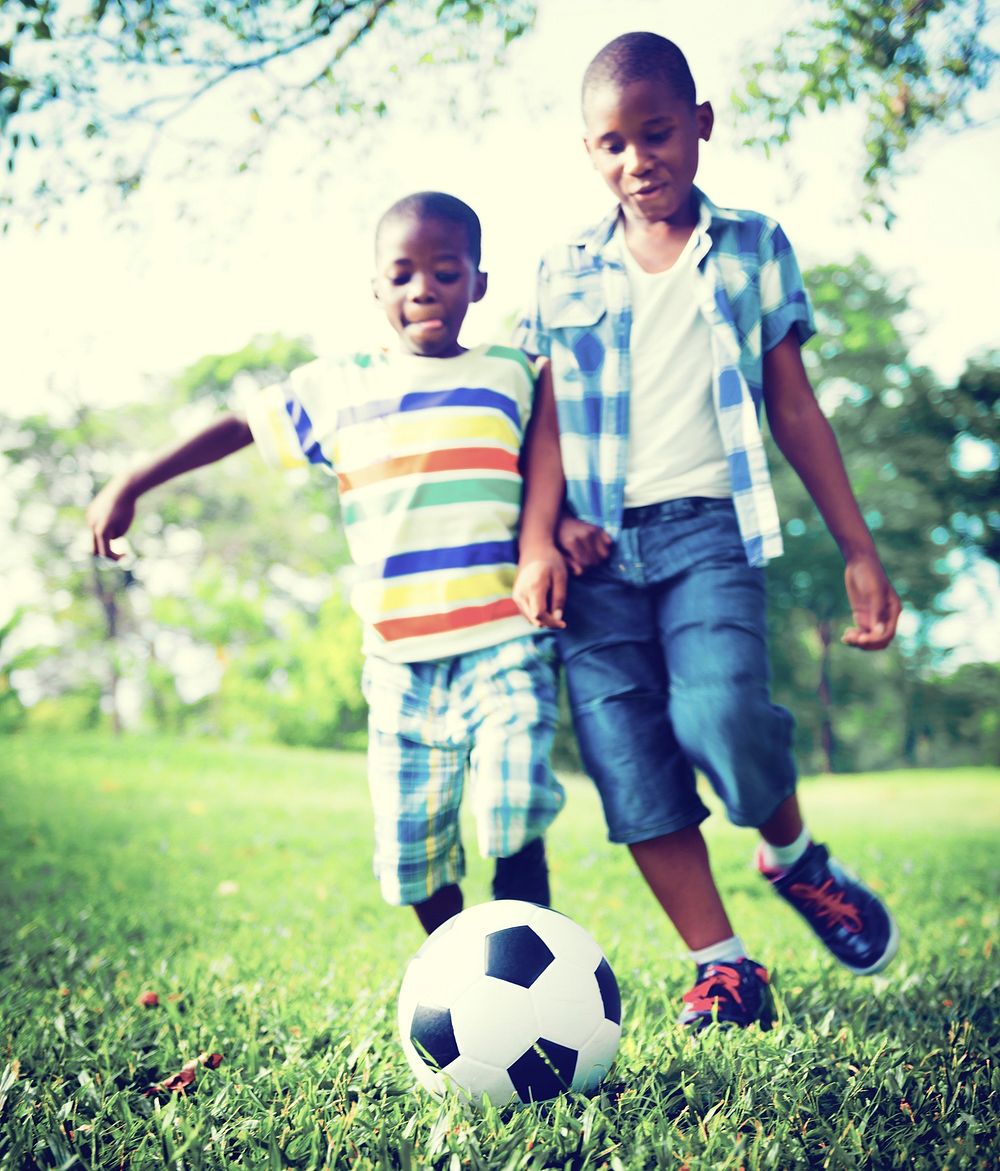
[515, 33, 899, 1028]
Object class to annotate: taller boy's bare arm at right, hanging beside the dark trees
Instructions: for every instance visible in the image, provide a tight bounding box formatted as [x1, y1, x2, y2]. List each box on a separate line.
[763, 333, 902, 651]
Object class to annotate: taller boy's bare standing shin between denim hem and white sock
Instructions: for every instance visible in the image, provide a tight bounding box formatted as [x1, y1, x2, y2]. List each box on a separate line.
[629, 826, 733, 951]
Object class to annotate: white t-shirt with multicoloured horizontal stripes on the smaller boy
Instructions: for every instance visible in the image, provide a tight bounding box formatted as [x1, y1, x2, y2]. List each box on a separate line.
[247, 345, 534, 663]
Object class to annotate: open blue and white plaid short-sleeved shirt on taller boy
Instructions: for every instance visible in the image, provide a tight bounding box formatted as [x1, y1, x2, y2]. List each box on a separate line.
[515, 189, 815, 566]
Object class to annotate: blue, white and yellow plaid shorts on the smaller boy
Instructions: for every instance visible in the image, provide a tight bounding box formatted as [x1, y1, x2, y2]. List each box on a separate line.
[362, 635, 566, 905]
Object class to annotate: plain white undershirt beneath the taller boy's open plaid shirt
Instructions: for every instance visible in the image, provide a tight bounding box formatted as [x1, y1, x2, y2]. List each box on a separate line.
[616, 222, 732, 508]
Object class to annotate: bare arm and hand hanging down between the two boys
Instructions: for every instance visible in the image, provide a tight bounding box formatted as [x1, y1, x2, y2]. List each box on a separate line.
[514, 362, 566, 628]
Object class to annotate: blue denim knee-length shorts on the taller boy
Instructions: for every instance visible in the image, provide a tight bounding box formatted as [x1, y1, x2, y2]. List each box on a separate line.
[559, 497, 796, 842]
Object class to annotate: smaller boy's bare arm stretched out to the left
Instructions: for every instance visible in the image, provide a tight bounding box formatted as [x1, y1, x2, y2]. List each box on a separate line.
[87, 415, 253, 561]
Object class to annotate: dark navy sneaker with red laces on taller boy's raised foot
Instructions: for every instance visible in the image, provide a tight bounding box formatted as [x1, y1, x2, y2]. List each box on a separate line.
[756, 842, 899, 975]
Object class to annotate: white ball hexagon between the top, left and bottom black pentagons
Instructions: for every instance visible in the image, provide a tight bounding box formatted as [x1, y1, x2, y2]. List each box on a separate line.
[451, 975, 539, 1069]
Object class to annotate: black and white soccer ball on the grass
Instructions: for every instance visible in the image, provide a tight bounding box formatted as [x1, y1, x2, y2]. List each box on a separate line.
[399, 899, 622, 1105]
